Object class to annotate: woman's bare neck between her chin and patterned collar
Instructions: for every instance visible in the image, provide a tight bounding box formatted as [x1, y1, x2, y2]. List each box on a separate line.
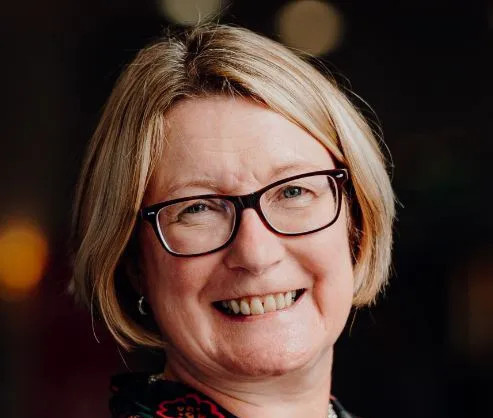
[164, 348, 333, 418]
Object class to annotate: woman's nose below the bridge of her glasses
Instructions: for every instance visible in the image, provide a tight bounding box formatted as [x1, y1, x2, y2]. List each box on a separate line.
[224, 209, 285, 276]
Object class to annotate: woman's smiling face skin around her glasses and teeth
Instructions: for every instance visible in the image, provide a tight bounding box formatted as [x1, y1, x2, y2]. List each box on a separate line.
[140, 97, 353, 377]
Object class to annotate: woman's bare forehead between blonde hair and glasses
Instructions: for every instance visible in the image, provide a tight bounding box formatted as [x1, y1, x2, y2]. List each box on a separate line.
[150, 96, 334, 198]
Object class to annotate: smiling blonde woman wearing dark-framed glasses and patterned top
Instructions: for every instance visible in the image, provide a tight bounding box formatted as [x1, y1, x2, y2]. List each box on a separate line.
[72, 26, 394, 417]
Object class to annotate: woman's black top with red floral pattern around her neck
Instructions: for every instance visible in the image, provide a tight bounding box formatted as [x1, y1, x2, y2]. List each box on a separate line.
[110, 373, 356, 418]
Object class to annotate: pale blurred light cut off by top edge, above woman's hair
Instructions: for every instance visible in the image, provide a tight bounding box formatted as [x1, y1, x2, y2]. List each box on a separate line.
[160, 0, 225, 26]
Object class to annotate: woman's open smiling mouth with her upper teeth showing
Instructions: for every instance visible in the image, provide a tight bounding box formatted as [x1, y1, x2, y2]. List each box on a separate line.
[212, 289, 306, 316]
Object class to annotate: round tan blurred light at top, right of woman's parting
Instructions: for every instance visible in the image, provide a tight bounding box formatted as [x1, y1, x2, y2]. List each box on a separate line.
[277, 0, 344, 55]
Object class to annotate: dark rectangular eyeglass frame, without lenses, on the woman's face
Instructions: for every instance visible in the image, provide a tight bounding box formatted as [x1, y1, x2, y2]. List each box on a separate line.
[139, 168, 349, 257]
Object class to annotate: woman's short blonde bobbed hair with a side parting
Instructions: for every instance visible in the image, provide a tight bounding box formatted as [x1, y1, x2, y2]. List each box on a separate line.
[71, 25, 394, 348]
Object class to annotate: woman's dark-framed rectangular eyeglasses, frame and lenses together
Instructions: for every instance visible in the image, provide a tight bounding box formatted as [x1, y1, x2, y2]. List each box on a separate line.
[140, 169, 348, 257]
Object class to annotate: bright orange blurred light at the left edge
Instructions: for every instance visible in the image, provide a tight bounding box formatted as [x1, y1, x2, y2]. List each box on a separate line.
[0, 221, 48, 300]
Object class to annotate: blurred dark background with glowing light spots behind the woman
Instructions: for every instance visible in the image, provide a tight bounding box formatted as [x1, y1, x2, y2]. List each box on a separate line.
[0, 0, 493, 418]
